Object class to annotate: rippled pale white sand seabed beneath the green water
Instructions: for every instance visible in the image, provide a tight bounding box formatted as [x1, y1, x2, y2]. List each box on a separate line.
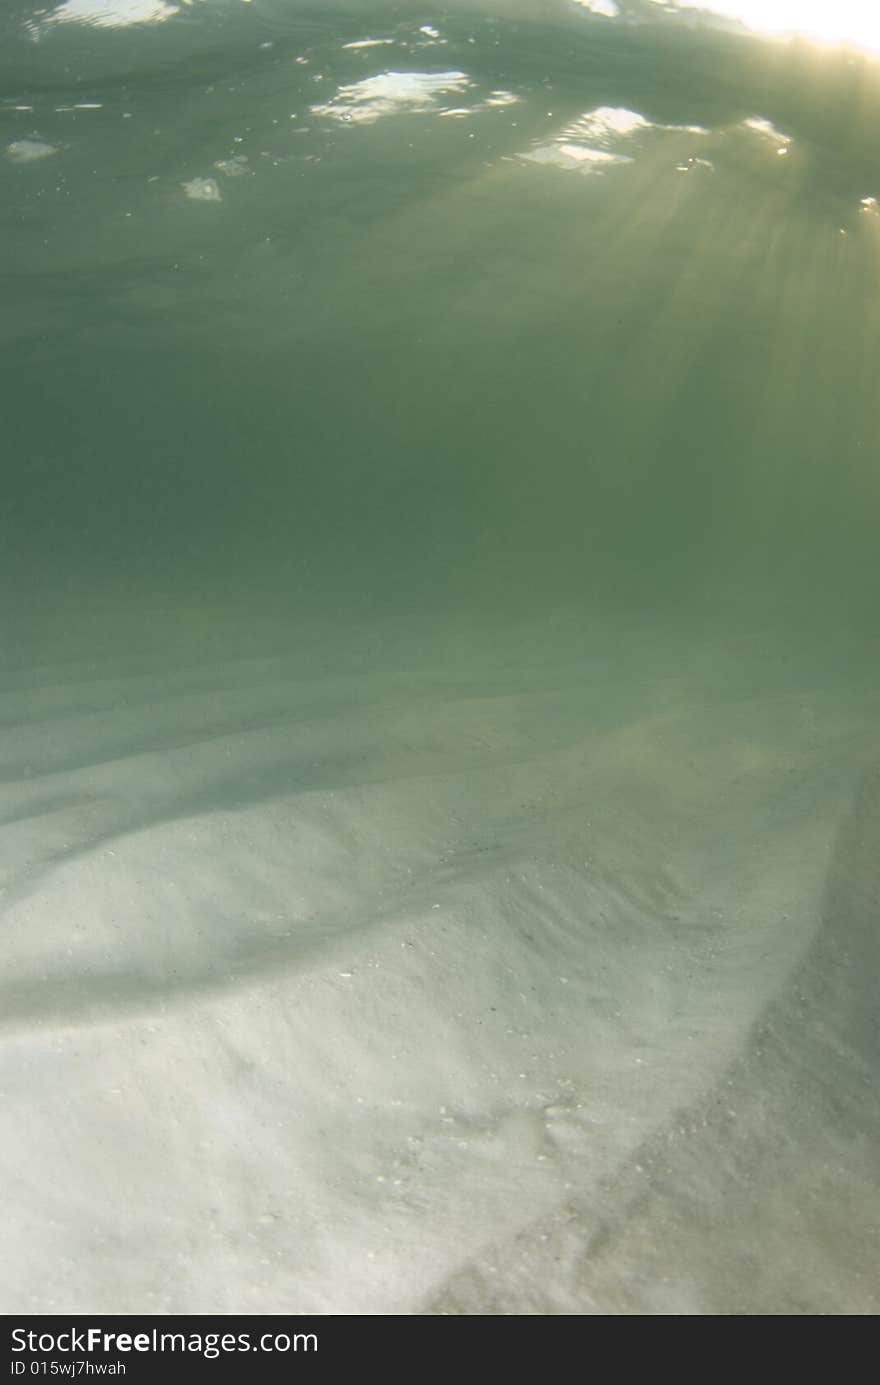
[0, 612, 880, 1314]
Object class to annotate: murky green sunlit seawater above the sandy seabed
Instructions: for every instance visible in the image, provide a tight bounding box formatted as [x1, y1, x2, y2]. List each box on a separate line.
[1, 3, 880, 642]
